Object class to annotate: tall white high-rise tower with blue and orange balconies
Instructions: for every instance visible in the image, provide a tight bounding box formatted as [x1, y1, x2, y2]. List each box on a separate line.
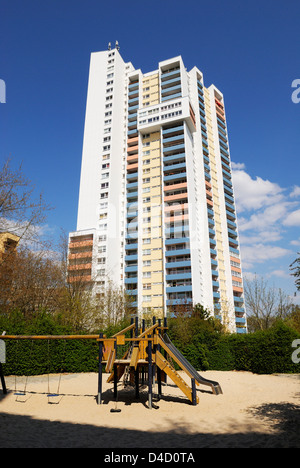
[69, 47, 246, 332]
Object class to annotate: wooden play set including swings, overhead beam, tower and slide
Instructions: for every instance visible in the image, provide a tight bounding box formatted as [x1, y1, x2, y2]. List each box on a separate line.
[0, 317, 222, 412]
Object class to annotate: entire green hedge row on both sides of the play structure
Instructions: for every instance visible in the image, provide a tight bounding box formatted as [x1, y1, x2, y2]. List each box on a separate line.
[0, 312, 300, 375]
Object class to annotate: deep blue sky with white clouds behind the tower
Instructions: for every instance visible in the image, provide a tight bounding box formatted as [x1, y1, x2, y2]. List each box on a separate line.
[0, 0, 300, 300]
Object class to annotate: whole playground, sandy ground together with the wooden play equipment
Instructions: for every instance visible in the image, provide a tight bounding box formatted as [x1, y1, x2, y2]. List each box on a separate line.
[0, 319, 300, 449]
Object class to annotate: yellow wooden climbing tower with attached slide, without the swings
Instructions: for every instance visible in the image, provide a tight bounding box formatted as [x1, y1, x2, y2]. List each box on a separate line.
[98, 317, 222, 408]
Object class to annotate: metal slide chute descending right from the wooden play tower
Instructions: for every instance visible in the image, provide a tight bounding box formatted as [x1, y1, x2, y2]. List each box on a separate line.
[160, 333, 223, 395]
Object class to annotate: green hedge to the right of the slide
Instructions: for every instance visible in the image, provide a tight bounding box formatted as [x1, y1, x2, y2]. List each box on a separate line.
[169, 322, 300, 374]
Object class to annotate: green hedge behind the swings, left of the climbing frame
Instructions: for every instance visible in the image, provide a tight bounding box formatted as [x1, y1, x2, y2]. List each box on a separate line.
[0, 312, 99, 375]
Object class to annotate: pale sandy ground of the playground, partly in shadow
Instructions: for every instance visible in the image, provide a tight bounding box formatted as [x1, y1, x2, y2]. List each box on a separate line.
[0, 371, 300, 449]
